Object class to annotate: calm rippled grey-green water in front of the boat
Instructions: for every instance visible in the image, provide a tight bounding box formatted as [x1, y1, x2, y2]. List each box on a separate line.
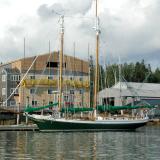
[0, 126, 160, 160]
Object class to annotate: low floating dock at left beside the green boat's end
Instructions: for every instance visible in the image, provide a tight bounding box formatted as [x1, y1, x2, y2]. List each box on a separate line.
[0, 124, 39, 131]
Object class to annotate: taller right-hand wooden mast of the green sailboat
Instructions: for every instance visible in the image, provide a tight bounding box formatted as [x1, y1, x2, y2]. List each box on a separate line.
[93, 0, 100, 109]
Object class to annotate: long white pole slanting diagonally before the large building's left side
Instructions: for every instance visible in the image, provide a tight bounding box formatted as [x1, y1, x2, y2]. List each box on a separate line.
[5, 55, 39, 103]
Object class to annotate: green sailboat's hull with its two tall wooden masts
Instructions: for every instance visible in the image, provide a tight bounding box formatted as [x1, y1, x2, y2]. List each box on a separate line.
[26, 0, 148, 131]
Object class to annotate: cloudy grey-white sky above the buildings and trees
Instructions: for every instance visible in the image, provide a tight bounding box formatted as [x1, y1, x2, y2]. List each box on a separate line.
[0, 0, 160, 67]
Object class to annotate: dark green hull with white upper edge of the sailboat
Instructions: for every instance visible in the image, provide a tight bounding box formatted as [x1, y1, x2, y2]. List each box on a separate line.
[30, 117, 148, 131]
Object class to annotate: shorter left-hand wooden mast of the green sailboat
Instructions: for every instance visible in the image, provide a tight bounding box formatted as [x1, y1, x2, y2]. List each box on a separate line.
[58, 15, 64, 111]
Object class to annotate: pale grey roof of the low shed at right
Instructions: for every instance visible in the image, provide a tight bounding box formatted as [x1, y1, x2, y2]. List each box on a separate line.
[99, 82, 160, 98]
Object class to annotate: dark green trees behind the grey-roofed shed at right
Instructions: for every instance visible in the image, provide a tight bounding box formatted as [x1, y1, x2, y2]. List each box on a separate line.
[95, 60, 160, 90]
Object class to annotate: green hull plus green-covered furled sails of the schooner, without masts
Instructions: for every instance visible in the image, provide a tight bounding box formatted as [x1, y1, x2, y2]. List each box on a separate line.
[25, 103, 153, 131]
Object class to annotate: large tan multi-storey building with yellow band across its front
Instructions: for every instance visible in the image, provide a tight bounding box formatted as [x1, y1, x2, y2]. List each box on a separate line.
[0, 52, 89, 108]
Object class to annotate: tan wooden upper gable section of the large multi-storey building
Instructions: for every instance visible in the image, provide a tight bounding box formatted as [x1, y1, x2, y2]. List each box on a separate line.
[0, 52, 89, 76]
